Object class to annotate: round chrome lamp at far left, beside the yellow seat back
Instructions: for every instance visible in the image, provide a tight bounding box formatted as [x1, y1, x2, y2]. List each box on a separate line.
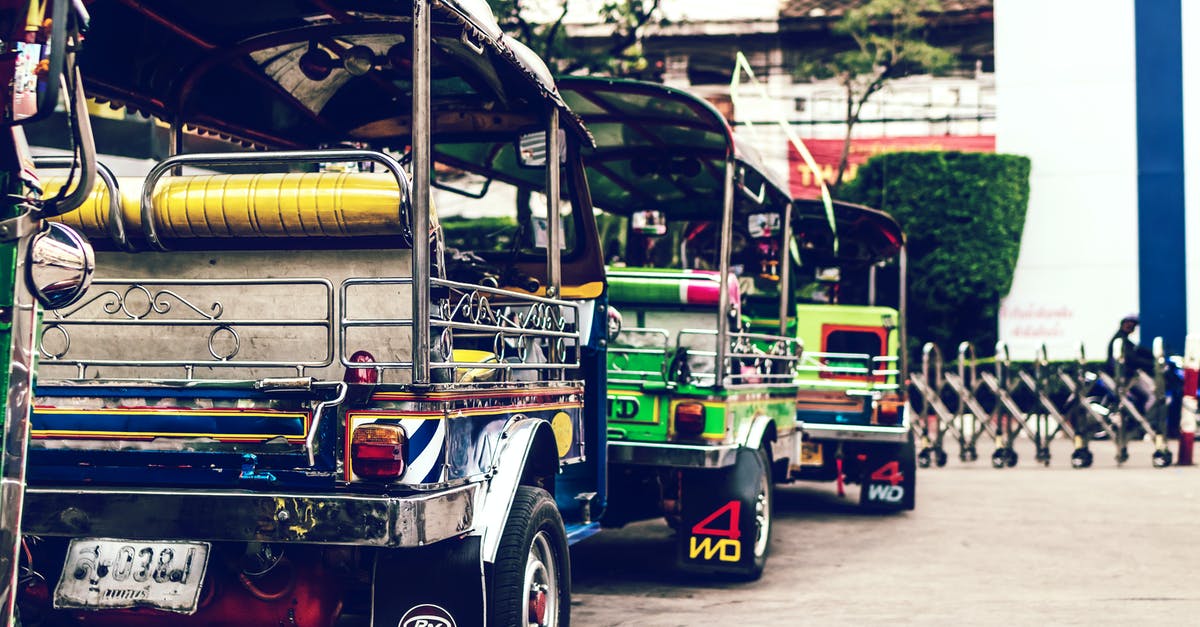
[26, 222, 96, 310]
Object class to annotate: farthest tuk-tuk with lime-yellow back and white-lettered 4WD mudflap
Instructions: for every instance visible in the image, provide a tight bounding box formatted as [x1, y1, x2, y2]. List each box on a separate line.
[787, 199, 917, 509]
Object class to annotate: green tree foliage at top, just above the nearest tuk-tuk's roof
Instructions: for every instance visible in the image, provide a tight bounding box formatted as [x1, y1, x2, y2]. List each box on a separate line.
[491, 0, 661, 76]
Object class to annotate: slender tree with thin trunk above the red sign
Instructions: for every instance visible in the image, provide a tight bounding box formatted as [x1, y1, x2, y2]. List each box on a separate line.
[793, 0, 955, 187]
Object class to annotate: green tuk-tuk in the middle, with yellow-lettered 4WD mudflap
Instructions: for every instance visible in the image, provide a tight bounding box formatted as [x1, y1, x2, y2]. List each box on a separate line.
[559, 78, 802, 578]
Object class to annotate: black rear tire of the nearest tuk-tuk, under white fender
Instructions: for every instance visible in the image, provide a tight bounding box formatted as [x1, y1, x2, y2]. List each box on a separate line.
[487, 485, 571, 627]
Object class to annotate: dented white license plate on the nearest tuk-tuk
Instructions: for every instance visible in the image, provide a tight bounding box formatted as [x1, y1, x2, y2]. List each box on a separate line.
[54, 538, 211, 614]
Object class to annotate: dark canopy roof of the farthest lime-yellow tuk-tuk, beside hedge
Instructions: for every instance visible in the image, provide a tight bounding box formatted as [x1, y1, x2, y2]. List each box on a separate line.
[792, 198, 904, 267]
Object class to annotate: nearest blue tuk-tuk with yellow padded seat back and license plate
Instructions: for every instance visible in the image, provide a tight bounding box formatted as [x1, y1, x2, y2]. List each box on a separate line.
[9, 0, 607, 626]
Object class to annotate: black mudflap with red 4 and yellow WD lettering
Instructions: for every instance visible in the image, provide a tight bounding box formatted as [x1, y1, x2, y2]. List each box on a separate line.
[678, 449, 762, 575]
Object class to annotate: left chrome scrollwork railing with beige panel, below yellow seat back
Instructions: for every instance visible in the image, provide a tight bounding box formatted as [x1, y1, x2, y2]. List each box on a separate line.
[38, 279, 334, 378]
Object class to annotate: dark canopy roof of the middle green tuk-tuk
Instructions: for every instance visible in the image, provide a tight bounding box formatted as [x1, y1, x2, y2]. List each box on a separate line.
[558, 77, 788, 220]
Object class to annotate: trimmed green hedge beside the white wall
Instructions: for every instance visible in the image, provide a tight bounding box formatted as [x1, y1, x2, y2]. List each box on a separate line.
[840, 153, 1030, 358]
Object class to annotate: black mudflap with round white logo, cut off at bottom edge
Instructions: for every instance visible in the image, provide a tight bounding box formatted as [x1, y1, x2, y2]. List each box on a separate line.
[371, 537, 485, 627]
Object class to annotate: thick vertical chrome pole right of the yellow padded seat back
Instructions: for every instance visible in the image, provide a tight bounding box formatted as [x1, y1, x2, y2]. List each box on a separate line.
[412, 0, 433, 384]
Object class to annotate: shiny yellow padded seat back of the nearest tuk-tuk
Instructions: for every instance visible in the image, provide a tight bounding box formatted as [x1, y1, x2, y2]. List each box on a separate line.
[46, 172, 403, 239]
